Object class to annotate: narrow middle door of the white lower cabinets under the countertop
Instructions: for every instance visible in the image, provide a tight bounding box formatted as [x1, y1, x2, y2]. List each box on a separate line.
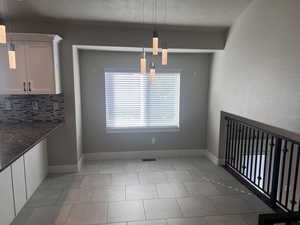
[11, 157, 27, 214]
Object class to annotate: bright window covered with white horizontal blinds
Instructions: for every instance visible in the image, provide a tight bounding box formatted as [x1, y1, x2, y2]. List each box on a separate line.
[105, 72, 180, 132]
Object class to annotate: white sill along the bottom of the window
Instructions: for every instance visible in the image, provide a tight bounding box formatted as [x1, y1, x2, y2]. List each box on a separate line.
[106, 127, 180, 134]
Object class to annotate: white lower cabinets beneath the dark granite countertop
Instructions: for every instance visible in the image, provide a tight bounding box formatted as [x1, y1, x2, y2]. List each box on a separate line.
[0, 139, 48, 225]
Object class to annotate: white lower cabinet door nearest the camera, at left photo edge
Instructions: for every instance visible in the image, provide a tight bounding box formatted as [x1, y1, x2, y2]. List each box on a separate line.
[0, 167, 15, 225]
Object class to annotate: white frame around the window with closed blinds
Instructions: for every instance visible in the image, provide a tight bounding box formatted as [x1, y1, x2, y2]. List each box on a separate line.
[104, 69, 182, 134]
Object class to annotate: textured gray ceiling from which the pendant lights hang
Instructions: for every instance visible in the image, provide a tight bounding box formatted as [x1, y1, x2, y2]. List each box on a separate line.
[1, 0, 251, 26]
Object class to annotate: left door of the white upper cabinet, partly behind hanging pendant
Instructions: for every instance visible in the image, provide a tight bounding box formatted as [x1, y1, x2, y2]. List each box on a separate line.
[0, 42, 27, 94]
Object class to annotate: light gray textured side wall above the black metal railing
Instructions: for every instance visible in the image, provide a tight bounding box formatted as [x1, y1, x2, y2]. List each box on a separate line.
[208, 0, 300, 158]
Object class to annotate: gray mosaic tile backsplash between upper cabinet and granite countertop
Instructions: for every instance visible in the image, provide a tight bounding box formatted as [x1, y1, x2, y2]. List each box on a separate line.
[0, 94, 64, 122]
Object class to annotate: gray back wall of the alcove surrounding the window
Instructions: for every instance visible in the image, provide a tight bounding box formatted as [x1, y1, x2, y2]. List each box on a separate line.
[79, 50, 211, 153]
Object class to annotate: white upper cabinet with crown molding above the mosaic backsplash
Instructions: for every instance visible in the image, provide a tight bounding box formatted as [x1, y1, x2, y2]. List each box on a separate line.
[0, 33, 62, 94]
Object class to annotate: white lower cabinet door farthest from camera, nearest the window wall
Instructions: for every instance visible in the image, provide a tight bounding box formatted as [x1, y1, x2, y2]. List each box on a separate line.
[24, 140, 48, 199]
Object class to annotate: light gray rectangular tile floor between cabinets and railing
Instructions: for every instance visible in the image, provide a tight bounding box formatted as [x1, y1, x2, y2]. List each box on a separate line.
[12, 158, 272, 225]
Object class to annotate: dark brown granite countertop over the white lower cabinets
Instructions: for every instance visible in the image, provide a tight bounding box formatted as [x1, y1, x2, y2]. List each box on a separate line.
[0, 122, 63, 172]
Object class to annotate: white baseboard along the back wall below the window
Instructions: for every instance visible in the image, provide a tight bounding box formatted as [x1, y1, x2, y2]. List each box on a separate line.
[83, 149, 206, 160]
